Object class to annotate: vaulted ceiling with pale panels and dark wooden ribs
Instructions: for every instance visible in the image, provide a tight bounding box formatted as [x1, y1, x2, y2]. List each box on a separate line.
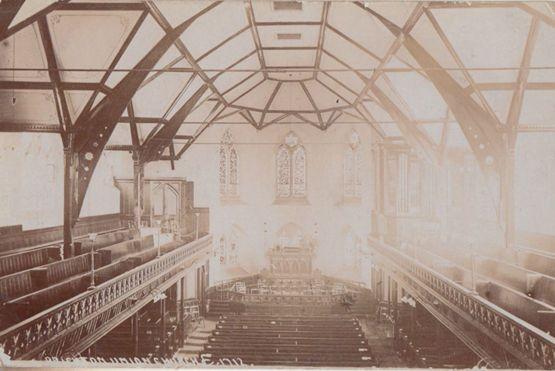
[0, 0, 555, 163]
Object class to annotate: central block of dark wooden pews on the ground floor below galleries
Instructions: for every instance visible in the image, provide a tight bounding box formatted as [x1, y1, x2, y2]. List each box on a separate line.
[200, 314, 375, 367]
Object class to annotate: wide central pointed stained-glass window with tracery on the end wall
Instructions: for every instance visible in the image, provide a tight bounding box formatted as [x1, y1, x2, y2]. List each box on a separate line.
[276, 132, 306, 199]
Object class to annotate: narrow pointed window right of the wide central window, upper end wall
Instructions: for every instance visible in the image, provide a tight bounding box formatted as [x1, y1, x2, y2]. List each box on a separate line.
[343, 131, 362, 198]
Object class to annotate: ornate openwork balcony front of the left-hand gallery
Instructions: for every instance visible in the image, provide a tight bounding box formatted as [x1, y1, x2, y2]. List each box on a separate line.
[0, 235, 212, 359]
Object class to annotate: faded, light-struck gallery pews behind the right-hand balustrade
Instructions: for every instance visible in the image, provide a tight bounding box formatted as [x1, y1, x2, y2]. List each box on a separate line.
[405, 234, 555, 334]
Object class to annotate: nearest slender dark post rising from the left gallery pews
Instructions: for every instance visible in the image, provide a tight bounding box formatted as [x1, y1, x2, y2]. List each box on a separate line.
[63, 145, 76, 259]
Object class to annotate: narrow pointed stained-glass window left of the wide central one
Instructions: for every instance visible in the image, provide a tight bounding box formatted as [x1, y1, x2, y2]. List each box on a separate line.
[218, 130, 239, 197]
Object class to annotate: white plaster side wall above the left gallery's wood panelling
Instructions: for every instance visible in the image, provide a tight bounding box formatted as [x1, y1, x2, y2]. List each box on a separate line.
[0, 133, 133, 229]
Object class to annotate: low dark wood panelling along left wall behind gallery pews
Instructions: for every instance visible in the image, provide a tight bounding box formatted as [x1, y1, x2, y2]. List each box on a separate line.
[0, 214, 126, 253]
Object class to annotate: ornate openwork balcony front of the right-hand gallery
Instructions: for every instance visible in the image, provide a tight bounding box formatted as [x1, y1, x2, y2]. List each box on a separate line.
[369, 238, 555, 370]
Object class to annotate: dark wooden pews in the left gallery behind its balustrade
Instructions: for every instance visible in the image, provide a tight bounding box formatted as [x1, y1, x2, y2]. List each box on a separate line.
[0, 222, 186, 330]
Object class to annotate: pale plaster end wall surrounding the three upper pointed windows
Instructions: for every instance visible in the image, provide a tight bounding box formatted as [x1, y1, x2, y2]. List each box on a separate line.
[145, 124, 374, 279]
